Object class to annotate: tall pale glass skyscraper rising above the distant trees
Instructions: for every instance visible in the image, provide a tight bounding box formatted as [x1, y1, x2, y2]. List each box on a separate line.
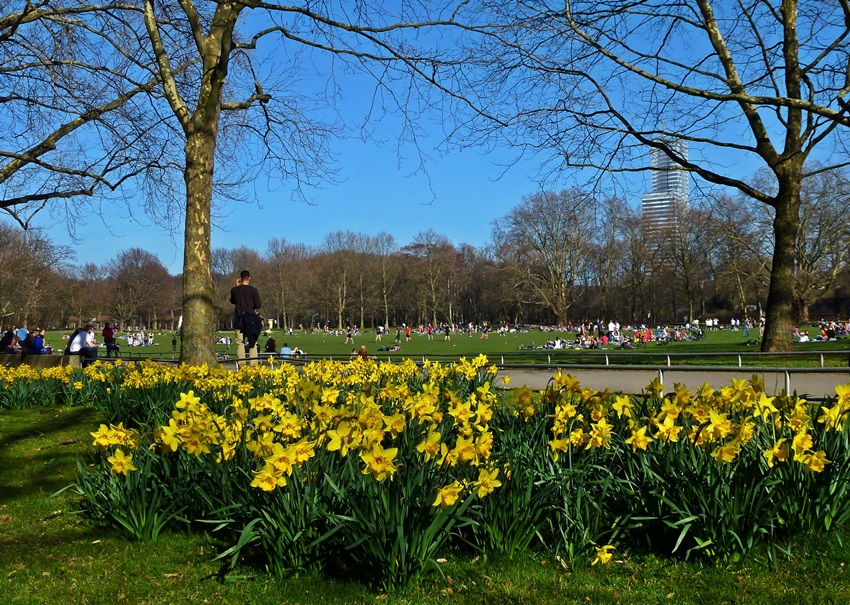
[642, 139, 689, 231]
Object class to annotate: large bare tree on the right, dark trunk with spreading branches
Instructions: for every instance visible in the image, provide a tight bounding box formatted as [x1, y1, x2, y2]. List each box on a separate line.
[464, 0, 850, 351]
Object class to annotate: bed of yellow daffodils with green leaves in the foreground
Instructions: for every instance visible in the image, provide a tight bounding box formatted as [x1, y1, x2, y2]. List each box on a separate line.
[6, 357, 850, 587]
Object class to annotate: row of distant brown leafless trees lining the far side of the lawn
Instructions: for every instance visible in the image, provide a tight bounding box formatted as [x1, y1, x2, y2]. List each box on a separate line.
[0, 177, 850, 329]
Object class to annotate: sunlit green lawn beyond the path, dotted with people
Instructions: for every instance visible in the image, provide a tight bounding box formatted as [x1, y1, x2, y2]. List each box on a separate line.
[43, 328, 850, 367]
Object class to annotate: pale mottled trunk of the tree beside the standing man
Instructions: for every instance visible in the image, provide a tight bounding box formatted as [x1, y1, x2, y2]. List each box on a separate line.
[180, 121, 218, 364]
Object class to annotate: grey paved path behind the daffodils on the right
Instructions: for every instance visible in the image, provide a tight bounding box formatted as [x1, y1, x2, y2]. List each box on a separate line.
[494, 367, 850, 400]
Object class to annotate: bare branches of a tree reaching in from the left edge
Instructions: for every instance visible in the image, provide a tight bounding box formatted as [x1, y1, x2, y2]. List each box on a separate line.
[0, 0, 186, 229]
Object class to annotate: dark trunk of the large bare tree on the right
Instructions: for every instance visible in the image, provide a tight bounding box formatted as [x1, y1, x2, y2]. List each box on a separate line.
[761, 175, 802, 352]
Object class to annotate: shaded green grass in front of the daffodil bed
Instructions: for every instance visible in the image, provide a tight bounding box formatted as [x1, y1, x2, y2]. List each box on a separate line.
[0, 408, 850, 605]
